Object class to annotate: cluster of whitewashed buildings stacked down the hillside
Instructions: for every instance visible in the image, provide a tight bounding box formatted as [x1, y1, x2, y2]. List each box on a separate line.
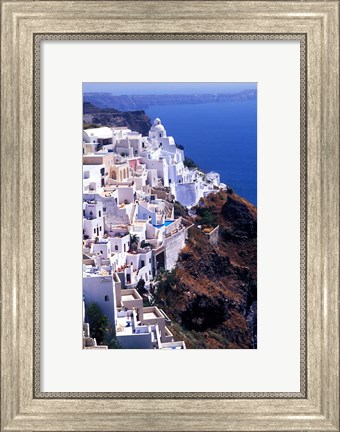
[83, 119, 220, 349]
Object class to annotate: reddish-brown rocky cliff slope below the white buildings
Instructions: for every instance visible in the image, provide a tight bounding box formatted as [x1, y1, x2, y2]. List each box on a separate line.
[155, 190, 257, 348]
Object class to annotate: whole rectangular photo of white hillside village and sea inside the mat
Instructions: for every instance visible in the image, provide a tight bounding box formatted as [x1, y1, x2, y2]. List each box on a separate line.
[81, 80, 257, 350]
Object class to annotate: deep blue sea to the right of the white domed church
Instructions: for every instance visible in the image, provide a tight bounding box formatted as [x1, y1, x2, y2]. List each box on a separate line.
[146, 100, 257, 205]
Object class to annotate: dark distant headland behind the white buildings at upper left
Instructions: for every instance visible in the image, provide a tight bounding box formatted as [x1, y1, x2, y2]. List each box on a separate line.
[83, 102, 151, 135]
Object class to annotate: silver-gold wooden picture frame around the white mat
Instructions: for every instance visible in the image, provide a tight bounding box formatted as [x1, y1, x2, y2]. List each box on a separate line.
[1, 0, 339, 431]
